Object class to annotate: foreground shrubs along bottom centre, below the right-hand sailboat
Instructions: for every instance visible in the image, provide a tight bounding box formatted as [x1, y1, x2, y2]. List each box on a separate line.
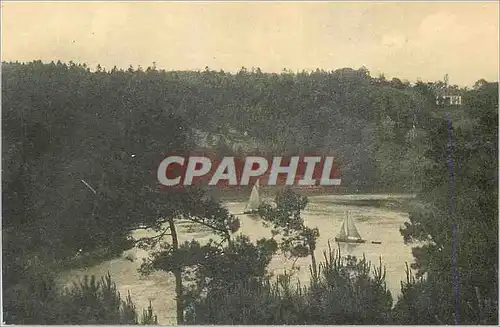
[188, 245, 392, 325]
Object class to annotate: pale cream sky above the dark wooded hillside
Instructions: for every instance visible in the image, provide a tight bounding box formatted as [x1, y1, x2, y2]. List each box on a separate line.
[1, 1, 499, 86]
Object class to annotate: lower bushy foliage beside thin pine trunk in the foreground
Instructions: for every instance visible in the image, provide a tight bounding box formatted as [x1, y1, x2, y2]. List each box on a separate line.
[140, 236, 277, 323]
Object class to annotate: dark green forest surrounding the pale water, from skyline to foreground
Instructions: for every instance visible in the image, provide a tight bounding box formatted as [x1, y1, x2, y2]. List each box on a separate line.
[2, 61, 498, 324]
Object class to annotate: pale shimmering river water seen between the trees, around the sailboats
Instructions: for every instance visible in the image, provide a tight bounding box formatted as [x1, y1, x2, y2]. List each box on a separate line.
[61, 195, 413, 325]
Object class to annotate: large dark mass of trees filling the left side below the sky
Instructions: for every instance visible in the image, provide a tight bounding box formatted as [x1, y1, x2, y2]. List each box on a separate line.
[2, 62, 193, 266]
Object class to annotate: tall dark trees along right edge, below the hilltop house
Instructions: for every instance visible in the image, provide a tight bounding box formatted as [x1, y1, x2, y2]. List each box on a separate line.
[401, 83, 498, 324]
